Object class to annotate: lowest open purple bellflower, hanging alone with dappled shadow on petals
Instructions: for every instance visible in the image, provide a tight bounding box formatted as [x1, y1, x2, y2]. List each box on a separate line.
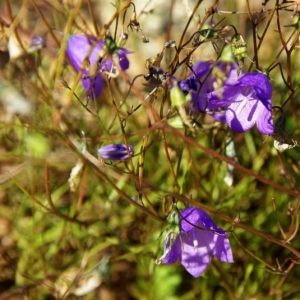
[156, 207, 233, 277]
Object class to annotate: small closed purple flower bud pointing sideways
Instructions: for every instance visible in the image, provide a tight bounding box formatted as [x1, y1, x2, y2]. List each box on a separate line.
[98, 144, 134, 160]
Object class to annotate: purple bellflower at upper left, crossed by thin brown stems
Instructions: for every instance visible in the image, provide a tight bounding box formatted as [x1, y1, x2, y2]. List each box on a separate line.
[66, 34, 130, 99]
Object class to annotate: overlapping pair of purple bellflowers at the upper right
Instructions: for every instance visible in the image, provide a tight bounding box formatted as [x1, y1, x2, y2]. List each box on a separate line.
[178, 61, 274, 135]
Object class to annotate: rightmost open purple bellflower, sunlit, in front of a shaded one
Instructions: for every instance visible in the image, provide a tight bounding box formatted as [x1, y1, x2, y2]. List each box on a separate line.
[207, 73, 274, 134]
